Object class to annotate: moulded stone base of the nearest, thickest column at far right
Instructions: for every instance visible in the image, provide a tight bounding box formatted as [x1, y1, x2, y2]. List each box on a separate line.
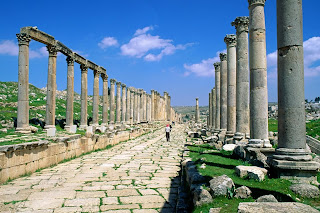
[269, 148, 320, 184]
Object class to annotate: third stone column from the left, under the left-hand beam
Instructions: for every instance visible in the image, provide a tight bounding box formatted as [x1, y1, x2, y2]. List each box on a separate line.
[64, 56, 74, 131]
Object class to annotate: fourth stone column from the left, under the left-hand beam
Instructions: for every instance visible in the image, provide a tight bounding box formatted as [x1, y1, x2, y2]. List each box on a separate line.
[80, 64, 88, 129]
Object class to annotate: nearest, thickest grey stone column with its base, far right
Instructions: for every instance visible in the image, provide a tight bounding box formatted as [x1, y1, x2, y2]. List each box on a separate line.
[272, 0, 319, 183]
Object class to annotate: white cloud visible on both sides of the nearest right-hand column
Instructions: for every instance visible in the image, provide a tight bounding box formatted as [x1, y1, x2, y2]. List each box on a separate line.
[267, 37, 320, 80]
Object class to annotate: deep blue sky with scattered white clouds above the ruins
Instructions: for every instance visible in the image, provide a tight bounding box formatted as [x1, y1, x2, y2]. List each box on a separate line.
[0, 0, 320, 106]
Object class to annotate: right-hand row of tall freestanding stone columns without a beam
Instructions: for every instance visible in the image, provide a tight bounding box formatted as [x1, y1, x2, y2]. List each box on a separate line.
[208, 0, 319, 181]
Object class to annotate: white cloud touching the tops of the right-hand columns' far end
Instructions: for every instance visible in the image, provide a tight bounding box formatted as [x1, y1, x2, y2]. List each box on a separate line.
[183, 50, 226, 77]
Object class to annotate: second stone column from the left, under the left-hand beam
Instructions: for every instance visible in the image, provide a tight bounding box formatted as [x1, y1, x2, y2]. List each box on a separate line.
[44, 45, 58, 129]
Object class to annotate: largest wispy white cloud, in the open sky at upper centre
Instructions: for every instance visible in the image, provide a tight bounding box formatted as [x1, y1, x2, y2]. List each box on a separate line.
[121, 27, 192, 61]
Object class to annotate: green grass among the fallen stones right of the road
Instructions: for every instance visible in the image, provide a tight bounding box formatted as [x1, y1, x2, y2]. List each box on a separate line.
[188, 145, 320, 212]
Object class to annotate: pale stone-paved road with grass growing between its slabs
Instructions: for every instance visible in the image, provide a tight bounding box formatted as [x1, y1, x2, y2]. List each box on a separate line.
[0, 125, 185, 213]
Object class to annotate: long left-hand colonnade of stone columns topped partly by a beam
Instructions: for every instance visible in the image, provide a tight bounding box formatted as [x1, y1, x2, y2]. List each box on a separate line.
[16, 27, 179, 133]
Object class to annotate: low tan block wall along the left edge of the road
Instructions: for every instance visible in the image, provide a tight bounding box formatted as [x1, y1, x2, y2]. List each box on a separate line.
[0, 128, 150, 183]
